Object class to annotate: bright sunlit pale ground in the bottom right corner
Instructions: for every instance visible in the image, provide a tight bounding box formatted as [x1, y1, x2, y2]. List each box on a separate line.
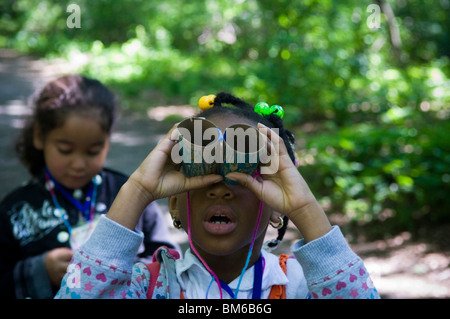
[353, 225, 450, 298]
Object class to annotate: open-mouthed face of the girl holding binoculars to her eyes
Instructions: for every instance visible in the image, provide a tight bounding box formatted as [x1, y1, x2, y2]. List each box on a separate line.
[169, 117, 272, 256]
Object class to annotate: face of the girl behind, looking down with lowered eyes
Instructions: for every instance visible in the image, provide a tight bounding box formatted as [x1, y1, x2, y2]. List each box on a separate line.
[34, 114, 109, 189]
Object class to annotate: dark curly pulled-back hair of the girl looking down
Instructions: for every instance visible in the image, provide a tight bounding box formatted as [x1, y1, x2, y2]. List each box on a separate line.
[15, 75, 117, 176]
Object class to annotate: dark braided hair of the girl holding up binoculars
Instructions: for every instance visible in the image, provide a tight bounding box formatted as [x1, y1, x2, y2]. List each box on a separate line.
[198, 92, 295, 247]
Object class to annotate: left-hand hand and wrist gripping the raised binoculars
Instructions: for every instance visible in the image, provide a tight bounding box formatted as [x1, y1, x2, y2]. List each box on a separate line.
[108, 124, 223, 229]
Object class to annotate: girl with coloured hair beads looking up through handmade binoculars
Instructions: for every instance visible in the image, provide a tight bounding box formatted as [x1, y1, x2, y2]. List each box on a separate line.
[56, 93, 379, 299]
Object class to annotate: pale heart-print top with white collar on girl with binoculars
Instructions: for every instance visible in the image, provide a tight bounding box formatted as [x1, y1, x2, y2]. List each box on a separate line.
[55, 217, 379, 299]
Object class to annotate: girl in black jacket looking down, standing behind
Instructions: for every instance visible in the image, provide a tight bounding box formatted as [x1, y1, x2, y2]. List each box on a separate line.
[0, 75, 174, 298]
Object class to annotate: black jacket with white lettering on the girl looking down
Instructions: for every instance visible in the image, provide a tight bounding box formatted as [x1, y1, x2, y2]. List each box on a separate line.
[0, 169, 176, 298]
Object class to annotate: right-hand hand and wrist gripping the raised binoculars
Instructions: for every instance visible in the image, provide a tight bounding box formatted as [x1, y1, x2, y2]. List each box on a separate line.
[226, 124, 331, 241]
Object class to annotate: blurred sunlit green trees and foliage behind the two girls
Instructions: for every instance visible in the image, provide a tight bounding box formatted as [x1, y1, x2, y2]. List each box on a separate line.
[0, 0, 450, 238]
